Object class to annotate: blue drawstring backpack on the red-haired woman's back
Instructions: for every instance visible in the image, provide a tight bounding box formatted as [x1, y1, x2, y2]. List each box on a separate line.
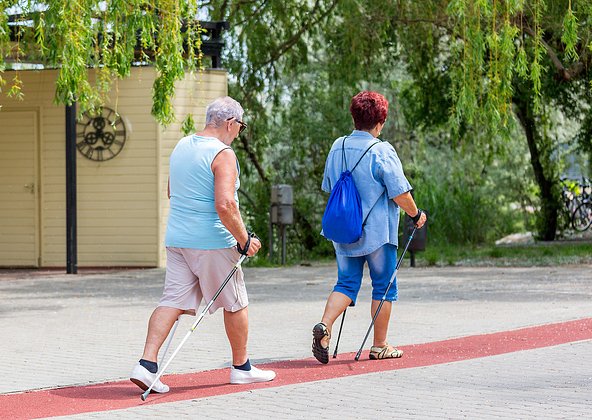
[322, 137, 380, 244]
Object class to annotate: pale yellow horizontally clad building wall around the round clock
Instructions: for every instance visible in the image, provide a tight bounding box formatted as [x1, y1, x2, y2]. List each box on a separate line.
[0, 67, 227, 267]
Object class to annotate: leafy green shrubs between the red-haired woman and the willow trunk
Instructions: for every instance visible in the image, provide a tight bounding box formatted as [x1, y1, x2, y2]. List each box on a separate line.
[403, 123, 533, 244]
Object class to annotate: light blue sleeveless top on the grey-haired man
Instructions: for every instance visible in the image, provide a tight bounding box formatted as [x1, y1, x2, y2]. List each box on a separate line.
[165, 134, 240, 249]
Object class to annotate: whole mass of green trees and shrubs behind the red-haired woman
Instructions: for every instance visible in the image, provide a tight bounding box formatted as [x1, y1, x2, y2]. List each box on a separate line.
[200, 0, 592, 259]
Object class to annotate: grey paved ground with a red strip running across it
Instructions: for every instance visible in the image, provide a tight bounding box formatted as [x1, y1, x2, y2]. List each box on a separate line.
[0, 265, 592, 419]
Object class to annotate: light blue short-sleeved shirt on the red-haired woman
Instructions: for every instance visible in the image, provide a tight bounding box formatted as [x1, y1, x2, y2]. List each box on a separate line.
[321, 130, 412, 257]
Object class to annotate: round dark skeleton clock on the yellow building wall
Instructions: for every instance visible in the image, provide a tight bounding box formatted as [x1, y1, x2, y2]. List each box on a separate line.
[76, 108, 126, 161]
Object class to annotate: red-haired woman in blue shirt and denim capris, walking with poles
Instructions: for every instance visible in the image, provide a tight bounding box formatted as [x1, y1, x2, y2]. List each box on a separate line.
[312, 91, 426, 363]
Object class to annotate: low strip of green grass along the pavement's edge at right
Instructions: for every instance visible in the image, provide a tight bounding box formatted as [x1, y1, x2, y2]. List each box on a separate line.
[412, 241, 592, 266]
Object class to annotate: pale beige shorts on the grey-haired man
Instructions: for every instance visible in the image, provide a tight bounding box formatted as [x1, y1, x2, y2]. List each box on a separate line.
[158, 247, 249, 315]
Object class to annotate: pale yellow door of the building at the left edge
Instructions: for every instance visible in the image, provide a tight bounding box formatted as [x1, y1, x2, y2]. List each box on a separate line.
[0, 109, 39, 267]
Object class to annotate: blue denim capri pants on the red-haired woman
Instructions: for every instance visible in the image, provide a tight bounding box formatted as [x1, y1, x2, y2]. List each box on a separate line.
[333, 244, 398, 306]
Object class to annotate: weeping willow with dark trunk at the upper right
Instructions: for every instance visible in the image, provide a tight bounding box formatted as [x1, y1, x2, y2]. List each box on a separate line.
[393, 0, 592, 240]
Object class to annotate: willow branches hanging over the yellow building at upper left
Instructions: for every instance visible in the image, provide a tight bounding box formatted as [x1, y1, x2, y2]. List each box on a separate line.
[0, 0, 202, 125]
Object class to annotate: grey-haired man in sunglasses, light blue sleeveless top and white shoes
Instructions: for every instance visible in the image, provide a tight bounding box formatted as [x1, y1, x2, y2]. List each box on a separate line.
[130, 96, 275, 393]
